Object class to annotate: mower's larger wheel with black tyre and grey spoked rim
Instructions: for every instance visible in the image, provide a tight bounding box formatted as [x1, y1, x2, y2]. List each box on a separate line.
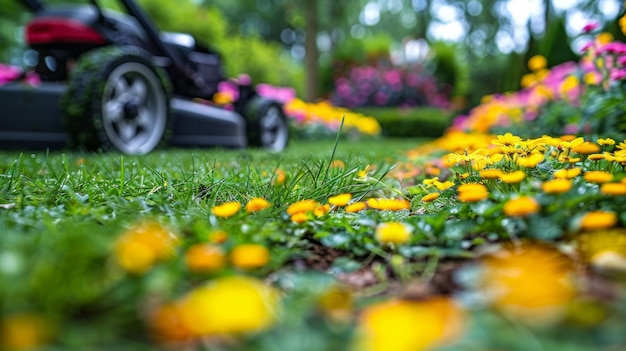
[63, 47, 171, 155]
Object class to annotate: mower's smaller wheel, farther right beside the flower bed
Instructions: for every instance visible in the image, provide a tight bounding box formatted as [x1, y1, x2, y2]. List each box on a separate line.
[245, 96, 289, 152]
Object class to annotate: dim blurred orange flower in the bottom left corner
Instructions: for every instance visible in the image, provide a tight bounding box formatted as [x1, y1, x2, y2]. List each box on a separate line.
[0, 313, 51, 351]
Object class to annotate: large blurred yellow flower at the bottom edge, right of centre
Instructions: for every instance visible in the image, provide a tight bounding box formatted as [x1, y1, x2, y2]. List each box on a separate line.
[355, 297, 463, 351]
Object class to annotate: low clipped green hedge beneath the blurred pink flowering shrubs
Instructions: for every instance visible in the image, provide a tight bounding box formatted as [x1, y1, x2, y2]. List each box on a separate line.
[357, 107, 453, 138]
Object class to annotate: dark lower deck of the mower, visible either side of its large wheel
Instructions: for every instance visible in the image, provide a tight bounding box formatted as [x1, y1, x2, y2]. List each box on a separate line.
[0, 82, 248, 149]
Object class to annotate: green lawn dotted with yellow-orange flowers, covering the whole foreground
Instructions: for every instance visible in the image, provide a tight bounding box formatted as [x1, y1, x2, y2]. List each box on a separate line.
[0, 133, 626, 351]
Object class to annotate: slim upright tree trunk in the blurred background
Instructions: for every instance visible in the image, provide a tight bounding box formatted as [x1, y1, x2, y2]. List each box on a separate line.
[304, 0, 319, 101]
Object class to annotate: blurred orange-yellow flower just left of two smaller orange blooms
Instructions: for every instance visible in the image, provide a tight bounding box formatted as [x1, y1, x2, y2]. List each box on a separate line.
[114, 221, 178, 274]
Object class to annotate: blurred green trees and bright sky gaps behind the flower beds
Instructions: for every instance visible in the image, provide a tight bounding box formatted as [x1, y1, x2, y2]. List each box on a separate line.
[0, 0, 624, 108]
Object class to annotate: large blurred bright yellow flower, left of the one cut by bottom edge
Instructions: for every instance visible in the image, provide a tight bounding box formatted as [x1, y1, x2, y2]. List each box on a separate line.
[179, 276, 279, 337]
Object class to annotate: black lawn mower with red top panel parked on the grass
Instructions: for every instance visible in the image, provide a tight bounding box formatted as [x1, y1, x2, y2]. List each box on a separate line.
[0, 0, 289, 155]
